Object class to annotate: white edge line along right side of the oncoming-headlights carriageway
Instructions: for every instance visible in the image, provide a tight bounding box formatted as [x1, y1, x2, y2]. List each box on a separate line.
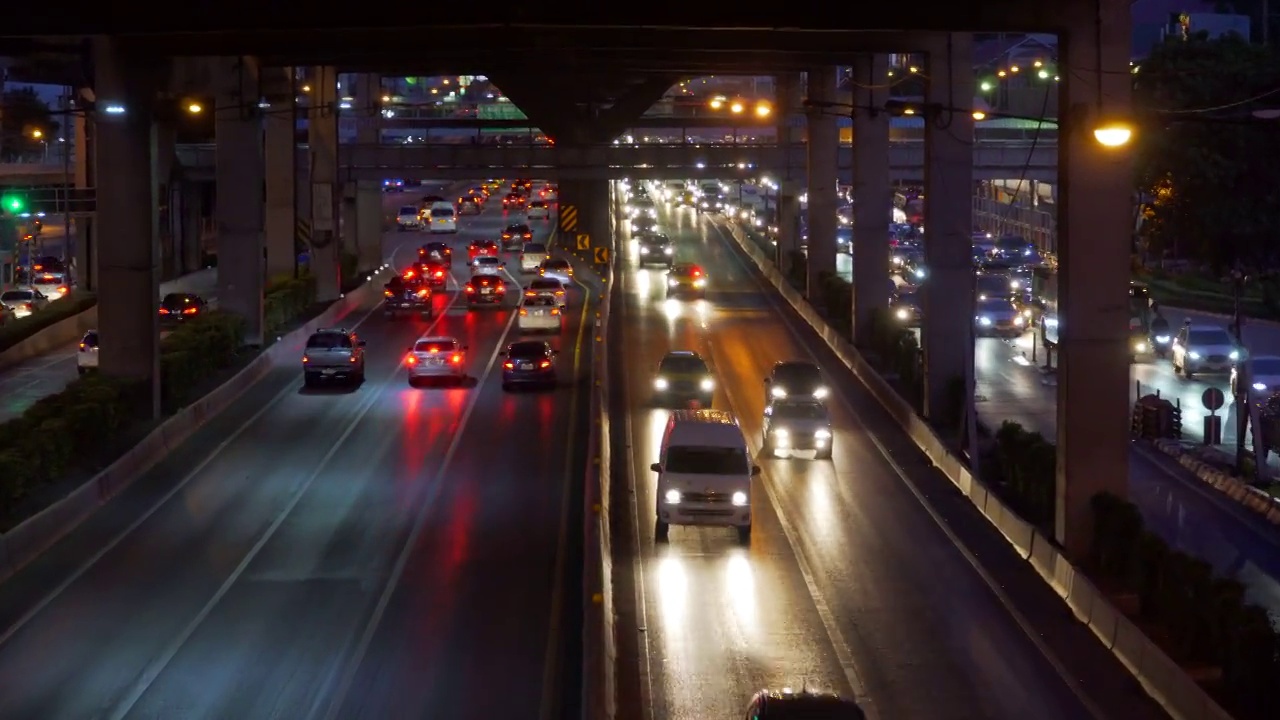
[713, 215, 1106, 720]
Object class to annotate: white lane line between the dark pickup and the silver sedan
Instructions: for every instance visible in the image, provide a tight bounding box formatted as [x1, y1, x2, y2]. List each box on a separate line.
[108, 286, 465, 720]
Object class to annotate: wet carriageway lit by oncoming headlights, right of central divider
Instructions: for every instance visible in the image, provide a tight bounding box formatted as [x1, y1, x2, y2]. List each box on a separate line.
[614, 196, 1161, 719]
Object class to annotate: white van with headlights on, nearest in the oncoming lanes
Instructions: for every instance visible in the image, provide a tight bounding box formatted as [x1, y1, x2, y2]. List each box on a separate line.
[650, 410, 760, 544]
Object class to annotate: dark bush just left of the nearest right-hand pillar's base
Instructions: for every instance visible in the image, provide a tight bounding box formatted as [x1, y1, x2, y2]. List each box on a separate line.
[995, 420, 1057, 520]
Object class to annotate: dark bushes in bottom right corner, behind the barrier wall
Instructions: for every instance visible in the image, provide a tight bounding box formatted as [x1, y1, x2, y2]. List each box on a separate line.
[1089, 493, 1280, 720]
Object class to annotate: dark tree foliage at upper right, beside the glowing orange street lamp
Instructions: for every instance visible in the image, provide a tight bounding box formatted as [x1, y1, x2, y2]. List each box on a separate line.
[1134, 33, 1280, 270]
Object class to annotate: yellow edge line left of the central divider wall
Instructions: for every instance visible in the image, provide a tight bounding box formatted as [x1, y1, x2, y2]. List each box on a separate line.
[538, 263, 608, 720]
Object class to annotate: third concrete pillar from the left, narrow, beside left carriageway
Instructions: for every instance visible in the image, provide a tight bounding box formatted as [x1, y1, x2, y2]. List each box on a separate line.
[264, 81, 298, 278]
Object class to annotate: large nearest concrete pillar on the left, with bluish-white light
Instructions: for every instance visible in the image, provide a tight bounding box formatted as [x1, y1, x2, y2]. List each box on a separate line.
[93, 36, 160, 416]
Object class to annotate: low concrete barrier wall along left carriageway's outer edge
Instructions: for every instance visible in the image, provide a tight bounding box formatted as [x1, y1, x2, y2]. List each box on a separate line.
[0, 274, 379, 580]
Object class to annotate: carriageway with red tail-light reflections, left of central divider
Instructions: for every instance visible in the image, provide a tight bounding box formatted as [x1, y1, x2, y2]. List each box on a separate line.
[0, 188, 591, 719]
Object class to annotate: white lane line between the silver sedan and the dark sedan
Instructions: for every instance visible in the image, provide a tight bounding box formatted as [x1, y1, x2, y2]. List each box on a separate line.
[317, 303, 518, 720]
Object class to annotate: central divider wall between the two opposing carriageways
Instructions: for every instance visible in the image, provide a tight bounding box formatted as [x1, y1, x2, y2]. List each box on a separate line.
[582, 256, 617, 720]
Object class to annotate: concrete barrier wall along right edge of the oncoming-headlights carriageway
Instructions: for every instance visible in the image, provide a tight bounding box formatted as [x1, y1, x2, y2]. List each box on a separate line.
[727, 223, 1231, 720]
